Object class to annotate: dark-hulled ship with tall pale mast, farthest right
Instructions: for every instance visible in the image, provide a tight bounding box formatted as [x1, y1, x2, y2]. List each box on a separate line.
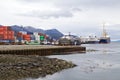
[99, 24, 111, 43]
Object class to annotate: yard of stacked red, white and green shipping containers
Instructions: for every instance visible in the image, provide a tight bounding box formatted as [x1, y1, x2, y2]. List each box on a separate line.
[0, 26, 48, 45]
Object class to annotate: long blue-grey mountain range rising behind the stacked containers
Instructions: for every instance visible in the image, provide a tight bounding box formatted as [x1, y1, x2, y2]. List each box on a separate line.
[10, 25, 63, 39]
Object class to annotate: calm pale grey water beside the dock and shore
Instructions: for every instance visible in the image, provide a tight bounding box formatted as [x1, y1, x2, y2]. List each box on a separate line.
[28, 42, 120, 80]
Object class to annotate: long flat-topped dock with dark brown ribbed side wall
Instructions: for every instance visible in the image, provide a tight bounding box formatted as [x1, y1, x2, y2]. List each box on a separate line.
[0, 45, 86, 56]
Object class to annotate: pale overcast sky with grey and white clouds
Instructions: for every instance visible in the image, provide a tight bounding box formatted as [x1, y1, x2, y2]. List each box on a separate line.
[0, 0, 120, 39]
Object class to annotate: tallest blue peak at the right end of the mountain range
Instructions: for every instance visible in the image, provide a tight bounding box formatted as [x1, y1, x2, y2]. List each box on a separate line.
[45, 29, 63, 39]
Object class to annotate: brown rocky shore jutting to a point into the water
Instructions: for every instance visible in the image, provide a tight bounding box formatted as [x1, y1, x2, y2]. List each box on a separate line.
[0, 55, 76, 80]
